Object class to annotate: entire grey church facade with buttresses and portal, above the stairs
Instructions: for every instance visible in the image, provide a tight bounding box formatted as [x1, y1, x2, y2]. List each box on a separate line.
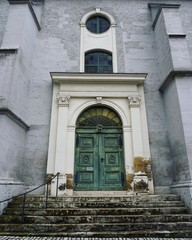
[0, 0, 192, 208]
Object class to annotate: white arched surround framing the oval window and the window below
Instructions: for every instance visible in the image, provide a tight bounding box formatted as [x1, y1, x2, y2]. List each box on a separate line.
[80, 8, 118, 73]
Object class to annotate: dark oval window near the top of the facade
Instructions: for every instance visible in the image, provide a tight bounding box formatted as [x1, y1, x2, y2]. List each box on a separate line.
[86, 16, 110, 33]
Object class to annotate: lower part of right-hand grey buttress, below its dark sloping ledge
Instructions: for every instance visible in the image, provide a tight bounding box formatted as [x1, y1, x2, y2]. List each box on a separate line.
[169, 77, 192, 209]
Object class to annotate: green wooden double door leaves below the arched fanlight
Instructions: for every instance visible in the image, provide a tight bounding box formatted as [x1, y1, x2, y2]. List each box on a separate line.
[74, 129, 125, 191]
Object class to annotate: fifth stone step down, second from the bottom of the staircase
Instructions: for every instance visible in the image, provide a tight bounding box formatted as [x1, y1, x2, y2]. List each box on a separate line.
[0, 222, 192, 233]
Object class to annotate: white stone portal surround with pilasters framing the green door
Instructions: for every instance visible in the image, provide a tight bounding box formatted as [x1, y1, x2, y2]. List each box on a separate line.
[47, 73, 150, 195]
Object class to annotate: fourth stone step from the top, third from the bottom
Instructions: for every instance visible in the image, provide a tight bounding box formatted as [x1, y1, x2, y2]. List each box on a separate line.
[0, 214, 192, 224]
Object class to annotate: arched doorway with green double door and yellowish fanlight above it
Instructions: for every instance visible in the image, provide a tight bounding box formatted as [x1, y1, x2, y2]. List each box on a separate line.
[74, 106, 125, 191]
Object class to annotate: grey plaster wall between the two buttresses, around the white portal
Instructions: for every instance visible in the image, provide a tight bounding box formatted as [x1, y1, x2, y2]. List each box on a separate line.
[25, 0, 172, 191]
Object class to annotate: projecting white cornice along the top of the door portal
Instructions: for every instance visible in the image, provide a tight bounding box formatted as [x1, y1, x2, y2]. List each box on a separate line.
[50, 72, 147, 85]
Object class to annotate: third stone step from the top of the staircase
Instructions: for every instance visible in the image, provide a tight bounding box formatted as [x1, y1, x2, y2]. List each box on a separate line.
[4, 207, 188, 216]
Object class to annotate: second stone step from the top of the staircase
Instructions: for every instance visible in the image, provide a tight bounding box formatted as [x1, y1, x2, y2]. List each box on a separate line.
[8, 201, 185, 209]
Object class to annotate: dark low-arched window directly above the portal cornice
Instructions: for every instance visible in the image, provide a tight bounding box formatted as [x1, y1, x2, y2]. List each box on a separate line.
[85, 51, 113, 73]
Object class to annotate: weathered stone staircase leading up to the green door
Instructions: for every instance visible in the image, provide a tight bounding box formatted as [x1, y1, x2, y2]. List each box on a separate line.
[0, 195, 192, 238]
